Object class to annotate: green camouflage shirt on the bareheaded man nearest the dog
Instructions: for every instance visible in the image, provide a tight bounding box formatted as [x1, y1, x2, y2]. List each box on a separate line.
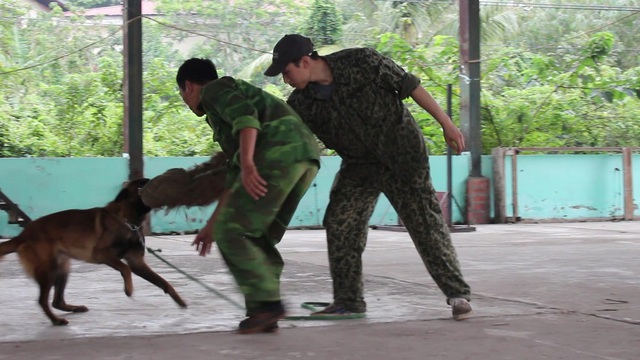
[200, 77, 320, 167]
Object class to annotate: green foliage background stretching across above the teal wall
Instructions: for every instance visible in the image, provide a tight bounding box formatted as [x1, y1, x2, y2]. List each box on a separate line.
[0, 0, 640, 157]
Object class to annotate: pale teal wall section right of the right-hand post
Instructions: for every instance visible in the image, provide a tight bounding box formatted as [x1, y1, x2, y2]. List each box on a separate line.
[505, 154, 640, 220]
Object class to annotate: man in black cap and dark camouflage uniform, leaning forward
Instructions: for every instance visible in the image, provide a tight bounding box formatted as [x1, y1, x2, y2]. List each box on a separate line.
[265, 34, 471, 320]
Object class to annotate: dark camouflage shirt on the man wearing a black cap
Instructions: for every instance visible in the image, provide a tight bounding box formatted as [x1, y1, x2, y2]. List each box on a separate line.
[287, 48, 428, 176]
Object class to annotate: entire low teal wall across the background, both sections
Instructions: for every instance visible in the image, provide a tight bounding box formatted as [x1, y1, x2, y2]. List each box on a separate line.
[5, 154, 640, 237]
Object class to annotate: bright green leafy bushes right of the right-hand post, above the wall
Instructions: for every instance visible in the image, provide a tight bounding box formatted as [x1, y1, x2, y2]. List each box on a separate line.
[482, 33, 640, 152]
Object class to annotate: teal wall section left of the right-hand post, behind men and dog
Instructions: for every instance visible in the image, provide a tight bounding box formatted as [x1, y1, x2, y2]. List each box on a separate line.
[0, 155, 469, 237]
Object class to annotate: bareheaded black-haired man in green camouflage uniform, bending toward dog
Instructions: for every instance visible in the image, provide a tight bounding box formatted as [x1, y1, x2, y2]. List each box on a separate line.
[176, 58, 320, 334]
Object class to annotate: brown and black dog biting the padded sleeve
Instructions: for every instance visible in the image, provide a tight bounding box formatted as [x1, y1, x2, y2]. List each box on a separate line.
[0, 179, 187, 325]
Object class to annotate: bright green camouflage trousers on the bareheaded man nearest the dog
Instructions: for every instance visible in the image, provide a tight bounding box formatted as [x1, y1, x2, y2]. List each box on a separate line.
[213, 161, 318, 314]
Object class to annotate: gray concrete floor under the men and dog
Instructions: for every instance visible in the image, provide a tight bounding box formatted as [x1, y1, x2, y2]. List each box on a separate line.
[0, 222, 640, 360]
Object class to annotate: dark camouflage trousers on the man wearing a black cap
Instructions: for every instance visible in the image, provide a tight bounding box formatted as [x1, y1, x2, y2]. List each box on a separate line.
[323, 163, 471, 313]
